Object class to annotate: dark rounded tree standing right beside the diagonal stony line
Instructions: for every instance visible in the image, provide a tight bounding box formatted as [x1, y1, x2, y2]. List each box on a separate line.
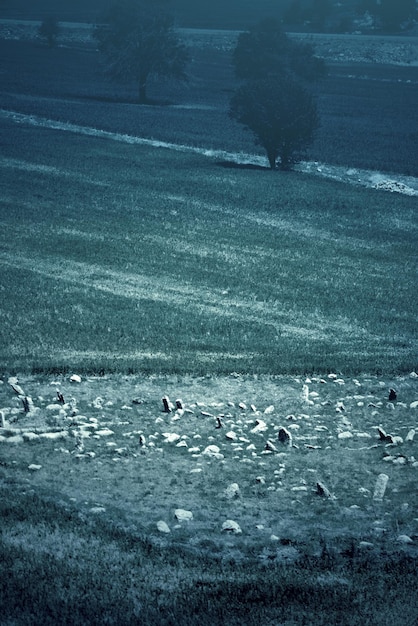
[230, 78, 319, 170]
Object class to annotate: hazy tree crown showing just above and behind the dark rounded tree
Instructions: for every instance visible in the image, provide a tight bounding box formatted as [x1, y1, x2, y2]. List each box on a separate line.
[232, 18, 326, 81]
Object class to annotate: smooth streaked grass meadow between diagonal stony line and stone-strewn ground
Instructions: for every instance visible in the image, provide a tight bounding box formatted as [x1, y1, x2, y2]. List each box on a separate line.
[0, 121, 418, 374]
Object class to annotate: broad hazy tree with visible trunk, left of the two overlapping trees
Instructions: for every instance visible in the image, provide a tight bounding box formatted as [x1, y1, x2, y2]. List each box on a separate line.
[94, 0, 188, 103]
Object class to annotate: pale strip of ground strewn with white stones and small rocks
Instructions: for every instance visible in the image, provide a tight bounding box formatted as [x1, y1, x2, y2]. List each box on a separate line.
[0, 373, 418, 560]
